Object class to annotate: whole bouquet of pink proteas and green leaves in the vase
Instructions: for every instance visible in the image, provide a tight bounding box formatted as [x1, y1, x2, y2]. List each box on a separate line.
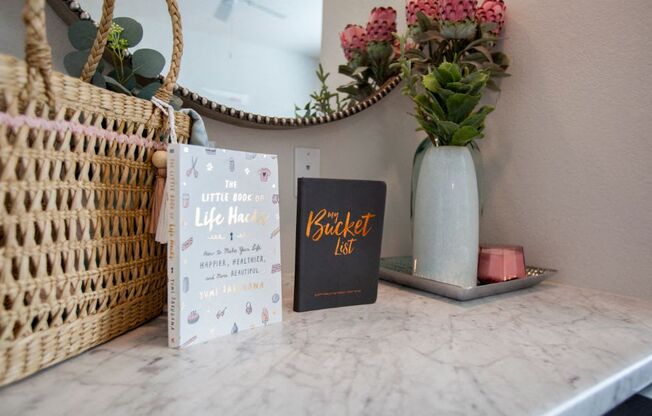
[394, 0, 509, 146]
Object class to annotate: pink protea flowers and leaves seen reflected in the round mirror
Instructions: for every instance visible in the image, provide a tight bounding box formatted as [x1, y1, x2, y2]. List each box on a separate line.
[337, 7, 399, 105]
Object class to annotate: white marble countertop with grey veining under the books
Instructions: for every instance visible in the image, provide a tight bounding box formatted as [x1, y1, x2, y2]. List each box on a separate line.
[0, 283, 652, 416]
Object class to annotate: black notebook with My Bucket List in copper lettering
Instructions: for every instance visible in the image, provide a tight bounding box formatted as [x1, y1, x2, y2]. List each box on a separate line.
[294, 178, 387, 312]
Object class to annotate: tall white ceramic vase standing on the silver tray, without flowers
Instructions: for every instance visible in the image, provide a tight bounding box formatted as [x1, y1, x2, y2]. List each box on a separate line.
[412, 146, 479, 288]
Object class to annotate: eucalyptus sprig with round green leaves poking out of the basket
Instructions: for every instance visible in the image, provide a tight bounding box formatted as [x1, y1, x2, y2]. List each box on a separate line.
[63, 17, 182, 109]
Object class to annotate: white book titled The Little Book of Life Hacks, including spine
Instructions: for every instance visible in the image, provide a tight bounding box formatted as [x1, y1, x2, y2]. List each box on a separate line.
[166, 144, 282, 347]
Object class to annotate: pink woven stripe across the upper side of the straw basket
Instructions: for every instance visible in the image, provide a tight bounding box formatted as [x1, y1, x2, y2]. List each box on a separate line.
[0, 112, 167, 150]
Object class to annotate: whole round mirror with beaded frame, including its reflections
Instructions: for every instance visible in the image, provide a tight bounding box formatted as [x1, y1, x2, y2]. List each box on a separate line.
[50, 0, 405, 128]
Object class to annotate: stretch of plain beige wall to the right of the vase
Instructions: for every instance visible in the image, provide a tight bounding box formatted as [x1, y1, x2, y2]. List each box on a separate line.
[482, 0, 652, 299]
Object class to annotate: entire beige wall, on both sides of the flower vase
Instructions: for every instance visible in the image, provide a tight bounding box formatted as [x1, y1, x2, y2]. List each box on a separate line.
[0, 0, 652, 299]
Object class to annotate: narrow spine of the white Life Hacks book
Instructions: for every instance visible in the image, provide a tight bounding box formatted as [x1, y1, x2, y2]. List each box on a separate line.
[165, 144, 181, 348]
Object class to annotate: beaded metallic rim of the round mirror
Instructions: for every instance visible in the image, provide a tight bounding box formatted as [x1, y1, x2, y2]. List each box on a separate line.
[48, 0, 401, 130]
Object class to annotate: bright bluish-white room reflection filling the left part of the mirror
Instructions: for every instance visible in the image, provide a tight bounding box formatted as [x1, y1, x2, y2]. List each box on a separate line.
[81, 0, 322, 117]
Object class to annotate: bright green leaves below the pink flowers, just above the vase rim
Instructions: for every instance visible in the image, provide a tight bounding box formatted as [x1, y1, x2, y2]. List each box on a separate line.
[401, 59, 494, 146]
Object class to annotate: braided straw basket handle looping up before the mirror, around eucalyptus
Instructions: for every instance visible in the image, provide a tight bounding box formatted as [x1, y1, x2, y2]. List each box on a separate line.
[81, 0, 183, 103]
